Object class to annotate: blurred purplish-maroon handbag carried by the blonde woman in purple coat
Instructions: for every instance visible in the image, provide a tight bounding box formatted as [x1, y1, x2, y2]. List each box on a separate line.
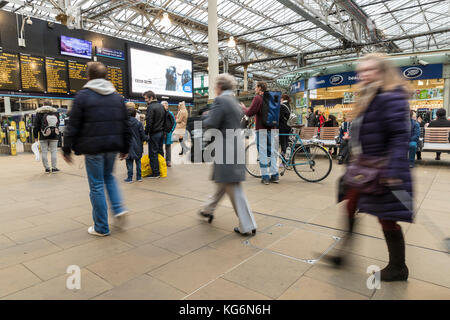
[343, 154, 388, 195]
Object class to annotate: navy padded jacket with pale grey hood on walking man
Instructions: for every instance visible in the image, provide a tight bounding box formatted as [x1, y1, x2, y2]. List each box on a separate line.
[63, 79, 130, 154]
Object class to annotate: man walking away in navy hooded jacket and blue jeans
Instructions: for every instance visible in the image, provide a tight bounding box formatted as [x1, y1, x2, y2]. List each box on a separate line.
[63, 62, 130, 236]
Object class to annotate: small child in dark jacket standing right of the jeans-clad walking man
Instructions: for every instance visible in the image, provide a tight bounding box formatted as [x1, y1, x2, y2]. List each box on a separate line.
[124, 108, 149, 183]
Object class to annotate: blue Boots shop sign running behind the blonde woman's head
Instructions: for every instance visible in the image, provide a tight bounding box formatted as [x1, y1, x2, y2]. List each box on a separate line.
[308, 64, 442, 90]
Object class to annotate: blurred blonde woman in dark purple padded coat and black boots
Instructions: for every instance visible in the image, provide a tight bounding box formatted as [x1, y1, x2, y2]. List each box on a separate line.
[333, 54, 413, 281]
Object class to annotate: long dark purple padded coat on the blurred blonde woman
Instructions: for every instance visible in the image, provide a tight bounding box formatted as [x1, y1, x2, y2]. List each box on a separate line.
[352, 88, 413, 222]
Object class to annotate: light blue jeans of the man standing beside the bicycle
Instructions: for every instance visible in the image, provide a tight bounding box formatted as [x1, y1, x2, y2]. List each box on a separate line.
[256, 130, 278, 180]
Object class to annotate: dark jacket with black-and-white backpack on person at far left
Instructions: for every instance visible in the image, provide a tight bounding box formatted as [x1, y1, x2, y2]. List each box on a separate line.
[33, 106, 59, 140]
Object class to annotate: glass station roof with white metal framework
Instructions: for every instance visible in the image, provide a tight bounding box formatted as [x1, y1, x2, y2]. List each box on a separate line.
[3, 0, 450, 79]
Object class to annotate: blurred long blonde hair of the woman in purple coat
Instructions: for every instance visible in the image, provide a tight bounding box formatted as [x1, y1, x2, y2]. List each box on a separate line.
[350, 53, 411, 119]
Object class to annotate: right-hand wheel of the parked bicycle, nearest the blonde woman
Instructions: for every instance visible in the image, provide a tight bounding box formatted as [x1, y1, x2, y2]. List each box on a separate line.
[292, 143, 333, 182]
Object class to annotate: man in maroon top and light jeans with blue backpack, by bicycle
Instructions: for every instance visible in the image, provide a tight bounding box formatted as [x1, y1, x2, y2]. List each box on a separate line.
[241, 81, 280, 185]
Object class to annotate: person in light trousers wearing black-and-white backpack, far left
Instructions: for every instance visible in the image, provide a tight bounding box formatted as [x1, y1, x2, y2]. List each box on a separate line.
[33, 101, 60, 173]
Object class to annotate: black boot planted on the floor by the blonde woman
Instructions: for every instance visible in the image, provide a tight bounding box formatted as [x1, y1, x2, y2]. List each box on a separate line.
[381, 229, 409, 281]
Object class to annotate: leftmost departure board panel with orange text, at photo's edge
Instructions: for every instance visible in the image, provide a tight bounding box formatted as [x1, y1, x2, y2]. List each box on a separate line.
[0, 52, 21, 91]
